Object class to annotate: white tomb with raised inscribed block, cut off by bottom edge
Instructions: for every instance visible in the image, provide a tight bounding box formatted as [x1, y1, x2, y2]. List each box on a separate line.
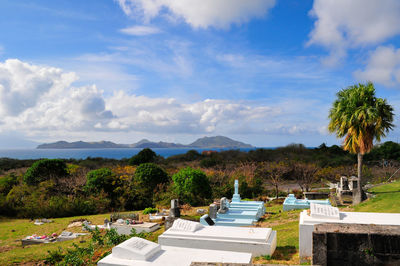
[97, 237, 251, 266]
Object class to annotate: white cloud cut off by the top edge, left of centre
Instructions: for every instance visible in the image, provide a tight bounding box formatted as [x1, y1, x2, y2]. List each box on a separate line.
[116, 0, 275, 28]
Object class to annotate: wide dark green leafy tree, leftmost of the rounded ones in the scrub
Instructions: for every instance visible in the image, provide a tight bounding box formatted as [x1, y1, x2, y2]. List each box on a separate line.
[24, 159, 68, 185]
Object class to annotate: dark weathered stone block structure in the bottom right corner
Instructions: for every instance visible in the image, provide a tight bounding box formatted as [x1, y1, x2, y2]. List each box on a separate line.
[312, 223, 400, 266]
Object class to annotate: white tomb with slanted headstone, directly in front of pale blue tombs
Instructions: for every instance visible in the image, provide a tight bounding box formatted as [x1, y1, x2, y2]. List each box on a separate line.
[158, 219, 276, 256]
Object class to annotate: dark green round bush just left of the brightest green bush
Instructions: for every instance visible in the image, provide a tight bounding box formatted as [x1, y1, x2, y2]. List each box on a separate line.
[134, 163, 169, 191]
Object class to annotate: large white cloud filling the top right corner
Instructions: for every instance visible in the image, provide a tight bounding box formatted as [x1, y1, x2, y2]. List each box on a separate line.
[308, 0, 400, 65]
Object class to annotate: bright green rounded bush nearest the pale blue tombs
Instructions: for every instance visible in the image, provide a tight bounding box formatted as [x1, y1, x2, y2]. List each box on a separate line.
[172, 167, 211, 206]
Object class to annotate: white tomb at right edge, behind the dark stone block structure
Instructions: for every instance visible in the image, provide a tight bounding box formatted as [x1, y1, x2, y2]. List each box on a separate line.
[299, 203, 400, 258]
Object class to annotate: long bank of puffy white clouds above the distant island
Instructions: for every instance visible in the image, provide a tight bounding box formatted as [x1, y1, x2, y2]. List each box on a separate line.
[0, 59, 279, 136]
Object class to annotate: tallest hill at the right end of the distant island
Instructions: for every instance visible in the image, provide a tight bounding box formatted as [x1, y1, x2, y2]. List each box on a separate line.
[189, 136, 253, 148]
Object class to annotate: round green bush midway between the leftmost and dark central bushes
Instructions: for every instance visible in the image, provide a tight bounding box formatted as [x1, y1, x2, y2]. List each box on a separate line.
[86, 168, 114, 193]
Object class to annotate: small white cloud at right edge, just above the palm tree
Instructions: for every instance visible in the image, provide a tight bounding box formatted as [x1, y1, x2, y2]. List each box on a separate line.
[354, 46, 400, 86]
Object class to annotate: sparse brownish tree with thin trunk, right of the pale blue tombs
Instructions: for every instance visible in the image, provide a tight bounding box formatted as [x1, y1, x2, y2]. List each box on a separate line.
[257, 161, 290, 198]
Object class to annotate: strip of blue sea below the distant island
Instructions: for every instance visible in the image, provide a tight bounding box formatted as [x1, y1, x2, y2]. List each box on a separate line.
[0, 148, 256, 159]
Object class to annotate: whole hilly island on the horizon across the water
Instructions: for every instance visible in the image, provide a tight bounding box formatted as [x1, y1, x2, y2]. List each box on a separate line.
[37, 136, 253, 149]
